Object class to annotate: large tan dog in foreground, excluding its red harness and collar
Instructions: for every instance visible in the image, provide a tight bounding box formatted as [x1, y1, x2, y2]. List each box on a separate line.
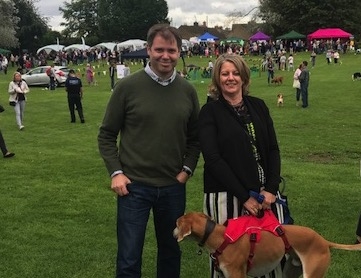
[173, 212, 361, 278]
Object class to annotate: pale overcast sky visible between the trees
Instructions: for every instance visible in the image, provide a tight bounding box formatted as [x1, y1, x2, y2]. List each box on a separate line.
[35, 0, 259, 31]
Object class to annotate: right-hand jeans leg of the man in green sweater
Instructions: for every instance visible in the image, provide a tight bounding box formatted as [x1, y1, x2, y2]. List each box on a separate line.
[153, 183, 186, 278]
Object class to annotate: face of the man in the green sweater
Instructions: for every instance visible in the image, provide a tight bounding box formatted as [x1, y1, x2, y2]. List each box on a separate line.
[147, 35, 180, 79]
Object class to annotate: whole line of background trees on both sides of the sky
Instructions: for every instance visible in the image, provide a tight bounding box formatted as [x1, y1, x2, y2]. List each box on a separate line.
[0, 0, 361, 52]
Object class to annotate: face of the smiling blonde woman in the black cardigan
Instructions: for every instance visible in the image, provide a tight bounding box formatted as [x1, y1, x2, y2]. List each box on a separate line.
[220, 61, 243, 96]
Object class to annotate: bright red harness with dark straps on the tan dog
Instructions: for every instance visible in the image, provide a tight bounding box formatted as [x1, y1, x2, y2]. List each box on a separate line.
[211, 210, 291, 272]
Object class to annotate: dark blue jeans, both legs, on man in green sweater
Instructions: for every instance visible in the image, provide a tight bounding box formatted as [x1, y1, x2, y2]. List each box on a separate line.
[116, 182, 186, 278]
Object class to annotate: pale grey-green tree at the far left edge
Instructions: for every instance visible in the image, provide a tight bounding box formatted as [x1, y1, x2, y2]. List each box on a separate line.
[0, 0, 19, 48]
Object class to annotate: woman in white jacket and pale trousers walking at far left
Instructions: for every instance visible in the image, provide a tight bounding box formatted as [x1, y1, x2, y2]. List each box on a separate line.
[8, 72, 29, 130]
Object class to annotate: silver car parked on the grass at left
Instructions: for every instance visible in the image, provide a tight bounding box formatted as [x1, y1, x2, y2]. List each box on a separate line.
[21, 66, 69, 86]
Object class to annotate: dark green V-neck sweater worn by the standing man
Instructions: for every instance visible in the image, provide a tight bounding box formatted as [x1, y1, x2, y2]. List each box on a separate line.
[98, 70, 200, 186]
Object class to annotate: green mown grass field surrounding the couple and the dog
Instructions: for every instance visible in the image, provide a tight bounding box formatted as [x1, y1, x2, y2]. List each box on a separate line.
[0, 50, 361, 278]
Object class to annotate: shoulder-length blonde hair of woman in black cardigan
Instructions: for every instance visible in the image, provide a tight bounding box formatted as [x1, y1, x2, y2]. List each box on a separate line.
[208, 54, 251, 99]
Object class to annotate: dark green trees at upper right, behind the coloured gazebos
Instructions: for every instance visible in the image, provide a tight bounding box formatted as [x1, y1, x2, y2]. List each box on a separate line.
[258, 0, 361, 36]
